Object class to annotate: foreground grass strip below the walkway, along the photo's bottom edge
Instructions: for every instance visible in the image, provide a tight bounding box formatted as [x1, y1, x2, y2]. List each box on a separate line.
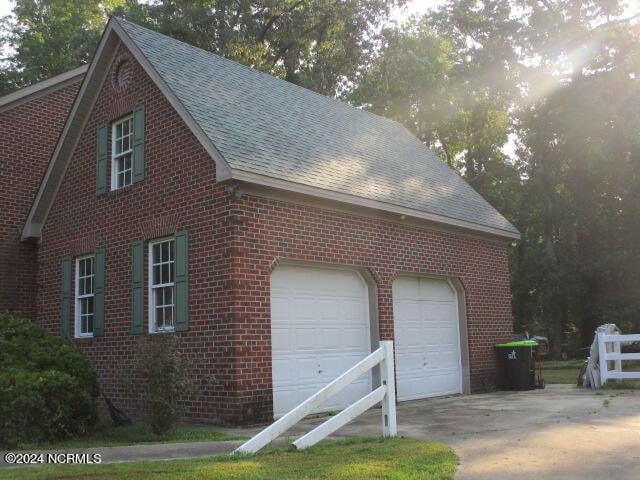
[0, 438, 458, 480]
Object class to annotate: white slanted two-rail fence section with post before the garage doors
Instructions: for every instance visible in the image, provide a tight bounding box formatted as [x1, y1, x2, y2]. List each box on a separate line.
[234, 341, 398, 453]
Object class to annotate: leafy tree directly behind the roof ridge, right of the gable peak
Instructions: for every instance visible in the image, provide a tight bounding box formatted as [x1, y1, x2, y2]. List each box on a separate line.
[116, 0, 405, 96]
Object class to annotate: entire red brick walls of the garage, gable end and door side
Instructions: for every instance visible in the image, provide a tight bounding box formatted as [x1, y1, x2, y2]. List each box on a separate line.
[38, 43, 511, 423]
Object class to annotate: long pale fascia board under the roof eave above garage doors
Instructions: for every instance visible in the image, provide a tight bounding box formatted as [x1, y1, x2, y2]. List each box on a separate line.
[232, 170, 520, 240]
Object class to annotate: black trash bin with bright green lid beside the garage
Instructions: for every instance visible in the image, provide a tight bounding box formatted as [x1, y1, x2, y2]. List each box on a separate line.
[496, 340, 538, 390]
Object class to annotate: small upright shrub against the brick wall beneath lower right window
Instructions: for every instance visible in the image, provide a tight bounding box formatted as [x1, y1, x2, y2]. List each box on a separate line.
[136, 333, 192, 435]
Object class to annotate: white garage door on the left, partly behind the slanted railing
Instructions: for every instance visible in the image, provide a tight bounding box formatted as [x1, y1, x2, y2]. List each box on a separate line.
[271, 266, 371, 417]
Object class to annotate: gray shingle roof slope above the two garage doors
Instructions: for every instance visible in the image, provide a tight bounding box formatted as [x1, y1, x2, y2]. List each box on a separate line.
[117, 19, 517, 234]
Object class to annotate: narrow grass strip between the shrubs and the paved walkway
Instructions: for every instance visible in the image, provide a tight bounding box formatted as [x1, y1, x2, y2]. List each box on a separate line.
[20, 420, 247, 450]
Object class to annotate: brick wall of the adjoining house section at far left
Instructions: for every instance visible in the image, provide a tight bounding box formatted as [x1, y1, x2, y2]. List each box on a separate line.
[0, 79, 81, 319]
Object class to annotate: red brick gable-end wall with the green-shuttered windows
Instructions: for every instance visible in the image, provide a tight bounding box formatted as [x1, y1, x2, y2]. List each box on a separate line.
[38, 47, 242, 423]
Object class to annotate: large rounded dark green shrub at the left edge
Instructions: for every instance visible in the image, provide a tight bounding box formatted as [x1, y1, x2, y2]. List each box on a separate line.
[0, 314, 98, 448]
